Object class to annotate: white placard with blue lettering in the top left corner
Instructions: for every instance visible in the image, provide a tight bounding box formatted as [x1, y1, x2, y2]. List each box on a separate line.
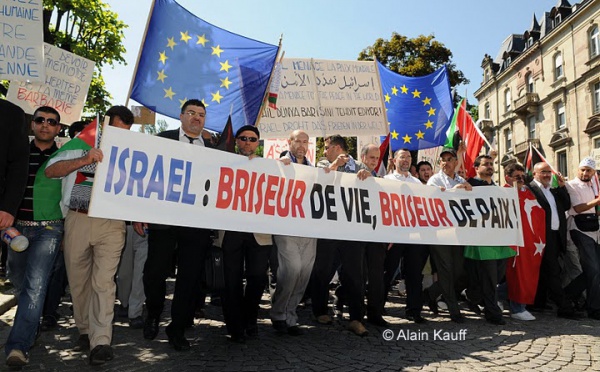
[0, 0, 45, 82]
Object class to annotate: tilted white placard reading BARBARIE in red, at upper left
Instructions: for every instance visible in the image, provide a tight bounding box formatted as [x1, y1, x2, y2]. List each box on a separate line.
[6, 44, 95, 125]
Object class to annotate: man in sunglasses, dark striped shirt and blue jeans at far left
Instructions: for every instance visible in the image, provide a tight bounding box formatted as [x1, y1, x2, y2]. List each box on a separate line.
[5, 106, 63, 367]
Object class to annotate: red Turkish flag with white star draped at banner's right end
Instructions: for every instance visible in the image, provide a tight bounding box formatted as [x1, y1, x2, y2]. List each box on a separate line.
[505, 185, 546, 304]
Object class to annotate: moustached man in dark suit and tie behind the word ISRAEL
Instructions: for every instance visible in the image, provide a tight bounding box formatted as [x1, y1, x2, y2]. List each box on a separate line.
[134, 99, 211, 351]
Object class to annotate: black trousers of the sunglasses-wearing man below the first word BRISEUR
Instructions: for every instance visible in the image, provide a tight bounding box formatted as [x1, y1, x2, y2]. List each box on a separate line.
[221, 231, 271, 336]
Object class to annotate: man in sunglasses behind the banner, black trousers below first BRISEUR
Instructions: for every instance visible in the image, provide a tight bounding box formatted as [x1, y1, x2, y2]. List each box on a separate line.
[222, 125, 273, 343]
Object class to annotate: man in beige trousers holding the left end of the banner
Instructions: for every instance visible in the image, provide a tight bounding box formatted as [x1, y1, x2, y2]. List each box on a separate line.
[45, 106, 133, 365]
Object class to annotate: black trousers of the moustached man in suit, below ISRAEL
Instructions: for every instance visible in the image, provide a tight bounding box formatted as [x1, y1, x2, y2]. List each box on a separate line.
[143, 226, 212, 333]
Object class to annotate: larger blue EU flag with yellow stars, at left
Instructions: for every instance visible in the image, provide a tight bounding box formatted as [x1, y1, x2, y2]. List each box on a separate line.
[131, 0, 278, 133]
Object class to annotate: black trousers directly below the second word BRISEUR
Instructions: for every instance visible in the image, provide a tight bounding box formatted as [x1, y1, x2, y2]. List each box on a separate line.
[384, 244, 429, 315]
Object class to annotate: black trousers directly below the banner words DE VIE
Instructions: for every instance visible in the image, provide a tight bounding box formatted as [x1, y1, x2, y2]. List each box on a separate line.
[311, 239, 366, 320]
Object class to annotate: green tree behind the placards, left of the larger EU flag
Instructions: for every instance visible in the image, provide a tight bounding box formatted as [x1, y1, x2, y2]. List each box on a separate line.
[0, 0, 127, 116]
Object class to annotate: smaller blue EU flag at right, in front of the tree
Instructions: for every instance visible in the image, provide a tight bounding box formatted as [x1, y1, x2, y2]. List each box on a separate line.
[377, 62, 454, 151]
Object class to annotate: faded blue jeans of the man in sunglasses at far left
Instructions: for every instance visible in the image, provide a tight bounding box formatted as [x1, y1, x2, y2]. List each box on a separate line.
[4, 222, 63, 355]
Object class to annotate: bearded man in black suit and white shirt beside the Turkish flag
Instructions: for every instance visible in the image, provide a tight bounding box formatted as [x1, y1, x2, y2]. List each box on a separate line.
[528, 162, 575, 319]
